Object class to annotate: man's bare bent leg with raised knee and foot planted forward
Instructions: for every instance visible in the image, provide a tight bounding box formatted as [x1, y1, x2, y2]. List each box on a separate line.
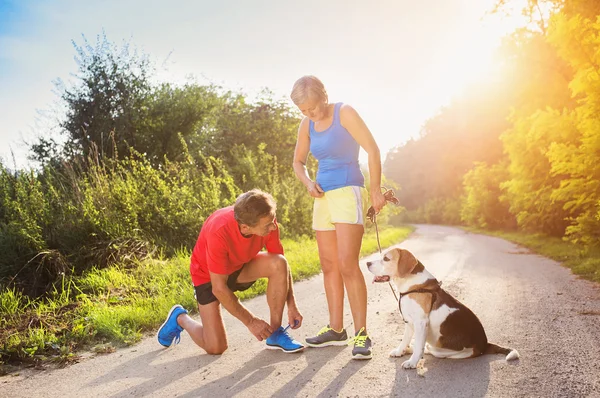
[237, 252, 290, 330]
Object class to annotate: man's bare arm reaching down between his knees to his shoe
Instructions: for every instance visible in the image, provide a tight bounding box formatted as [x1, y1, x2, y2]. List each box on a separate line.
[210, 272, 273, 341]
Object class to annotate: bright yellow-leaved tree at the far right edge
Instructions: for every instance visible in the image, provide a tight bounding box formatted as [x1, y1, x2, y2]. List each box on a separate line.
[548, 14, 600, 245]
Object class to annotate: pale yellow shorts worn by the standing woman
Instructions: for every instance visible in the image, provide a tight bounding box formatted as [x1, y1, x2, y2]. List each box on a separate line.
[313, 186, 367, 231]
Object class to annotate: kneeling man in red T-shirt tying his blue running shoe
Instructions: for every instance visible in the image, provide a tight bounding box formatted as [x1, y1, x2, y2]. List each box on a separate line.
[158, 189, 304, 355]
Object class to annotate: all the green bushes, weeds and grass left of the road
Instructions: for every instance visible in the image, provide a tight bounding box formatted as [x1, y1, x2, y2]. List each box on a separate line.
[0, 36, 411, 372]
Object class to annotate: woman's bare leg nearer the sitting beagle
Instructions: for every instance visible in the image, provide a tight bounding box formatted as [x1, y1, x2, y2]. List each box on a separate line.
[335, 223, 367, 332]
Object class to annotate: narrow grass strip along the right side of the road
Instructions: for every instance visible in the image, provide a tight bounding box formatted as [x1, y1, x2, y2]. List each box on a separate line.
[465, 228, 600, 282]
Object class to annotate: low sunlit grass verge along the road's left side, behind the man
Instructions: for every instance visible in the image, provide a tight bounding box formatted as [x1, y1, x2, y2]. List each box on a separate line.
[0, 227, 413, 368]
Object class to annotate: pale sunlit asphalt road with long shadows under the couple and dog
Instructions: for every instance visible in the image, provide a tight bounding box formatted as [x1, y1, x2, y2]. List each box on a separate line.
[0, 225, 600, 397]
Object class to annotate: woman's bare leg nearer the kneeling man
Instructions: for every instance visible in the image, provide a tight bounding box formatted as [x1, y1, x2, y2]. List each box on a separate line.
[316, 231, 344, 332]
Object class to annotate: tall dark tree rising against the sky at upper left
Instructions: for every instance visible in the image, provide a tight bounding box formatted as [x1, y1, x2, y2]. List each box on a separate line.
[57, 34, 153, 159]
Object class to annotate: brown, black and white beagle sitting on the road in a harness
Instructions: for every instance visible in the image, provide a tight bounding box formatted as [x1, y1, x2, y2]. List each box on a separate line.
[367, 249, 519, 369]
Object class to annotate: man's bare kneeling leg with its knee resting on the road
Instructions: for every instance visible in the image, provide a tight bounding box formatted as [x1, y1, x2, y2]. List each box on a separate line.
[177, 301, 227, 355]
